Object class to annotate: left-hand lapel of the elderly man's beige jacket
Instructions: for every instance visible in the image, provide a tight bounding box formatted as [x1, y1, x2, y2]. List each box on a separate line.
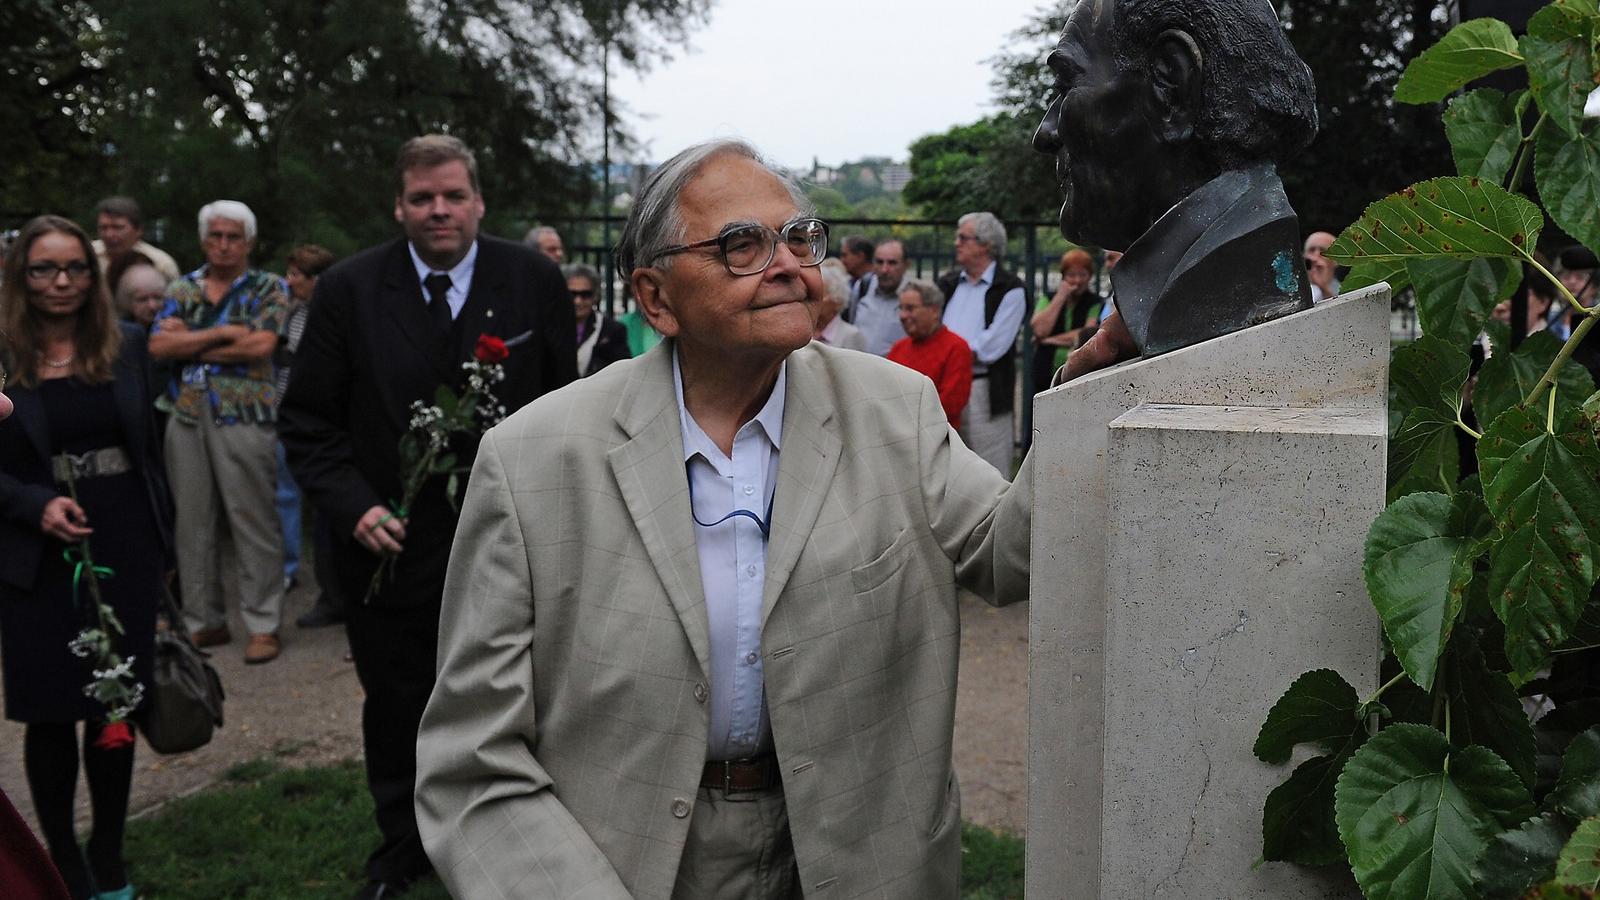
[606, 341, 710, 676]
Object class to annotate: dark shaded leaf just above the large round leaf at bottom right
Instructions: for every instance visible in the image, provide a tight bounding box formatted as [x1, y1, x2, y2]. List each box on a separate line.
[1445, 636, 1538, 790]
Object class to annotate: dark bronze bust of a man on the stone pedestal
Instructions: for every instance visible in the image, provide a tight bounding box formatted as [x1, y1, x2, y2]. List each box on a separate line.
[1034, 0, 1317, 368]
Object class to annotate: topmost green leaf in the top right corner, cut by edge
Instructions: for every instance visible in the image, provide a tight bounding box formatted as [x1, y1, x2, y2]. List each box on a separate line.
[1518, 0, 1595, 136]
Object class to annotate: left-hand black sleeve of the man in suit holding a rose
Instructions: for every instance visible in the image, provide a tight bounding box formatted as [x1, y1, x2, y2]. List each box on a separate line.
[278, 262, 382, 536]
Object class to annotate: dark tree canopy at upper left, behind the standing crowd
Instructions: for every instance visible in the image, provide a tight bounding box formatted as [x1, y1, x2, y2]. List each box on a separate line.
[0, 0, 710, 261]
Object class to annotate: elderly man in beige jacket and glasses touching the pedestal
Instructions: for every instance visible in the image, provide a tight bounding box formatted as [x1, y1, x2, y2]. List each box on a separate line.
[418, 141, 1032, 900]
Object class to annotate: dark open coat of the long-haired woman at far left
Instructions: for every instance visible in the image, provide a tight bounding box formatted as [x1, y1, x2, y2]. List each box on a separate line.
[0, 322, 173, 591]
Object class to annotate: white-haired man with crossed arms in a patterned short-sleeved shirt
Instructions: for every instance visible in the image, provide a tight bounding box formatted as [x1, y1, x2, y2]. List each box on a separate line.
[150, 200, 290, 663]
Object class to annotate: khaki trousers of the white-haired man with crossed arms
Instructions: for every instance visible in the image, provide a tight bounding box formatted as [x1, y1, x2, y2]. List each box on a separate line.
[166, 418, 283, 634]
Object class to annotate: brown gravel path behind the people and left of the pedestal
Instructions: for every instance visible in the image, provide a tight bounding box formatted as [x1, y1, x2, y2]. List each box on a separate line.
[0, 585, 1027, 834]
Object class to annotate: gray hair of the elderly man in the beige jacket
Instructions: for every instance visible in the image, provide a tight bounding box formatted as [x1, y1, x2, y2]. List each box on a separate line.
[616, 139, 816, 280]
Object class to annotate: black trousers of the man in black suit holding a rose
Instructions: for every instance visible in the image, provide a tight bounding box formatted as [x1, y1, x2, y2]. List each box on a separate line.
[344, 594, 440, 882]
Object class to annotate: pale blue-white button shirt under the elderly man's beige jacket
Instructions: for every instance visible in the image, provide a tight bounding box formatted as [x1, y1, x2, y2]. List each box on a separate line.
[672, 349, 789, 761]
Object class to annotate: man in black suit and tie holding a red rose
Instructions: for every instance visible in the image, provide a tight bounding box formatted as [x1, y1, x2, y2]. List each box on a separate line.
[278, 135, 576, 898]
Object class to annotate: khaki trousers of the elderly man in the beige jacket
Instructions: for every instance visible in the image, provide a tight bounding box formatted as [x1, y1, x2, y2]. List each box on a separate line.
[672, 786, 803, 900]
